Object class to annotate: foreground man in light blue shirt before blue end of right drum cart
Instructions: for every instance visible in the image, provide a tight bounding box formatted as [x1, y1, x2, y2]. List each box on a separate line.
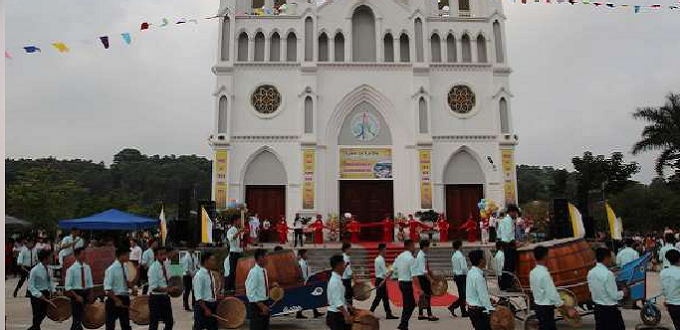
[588, 248, 626, 330]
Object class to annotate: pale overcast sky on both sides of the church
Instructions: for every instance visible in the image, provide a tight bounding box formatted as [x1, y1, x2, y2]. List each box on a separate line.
[5, 0, 680, 182]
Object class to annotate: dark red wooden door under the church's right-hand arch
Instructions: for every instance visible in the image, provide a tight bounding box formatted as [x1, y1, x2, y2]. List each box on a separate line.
[446, 184, 484, 238]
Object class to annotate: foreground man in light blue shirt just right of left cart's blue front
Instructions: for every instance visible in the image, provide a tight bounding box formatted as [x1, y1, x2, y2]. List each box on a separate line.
[326, 255, 352, 330]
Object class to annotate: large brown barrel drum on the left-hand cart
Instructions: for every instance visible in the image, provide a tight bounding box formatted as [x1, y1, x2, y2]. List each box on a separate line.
[236, 250, 303, 290]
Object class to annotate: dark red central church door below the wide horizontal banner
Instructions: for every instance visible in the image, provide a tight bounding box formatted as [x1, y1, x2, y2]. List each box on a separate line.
[340, 180, 394, 241]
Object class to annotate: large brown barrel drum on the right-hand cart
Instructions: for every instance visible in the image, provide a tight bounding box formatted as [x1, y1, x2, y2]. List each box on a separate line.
[517, 238, 595, 303]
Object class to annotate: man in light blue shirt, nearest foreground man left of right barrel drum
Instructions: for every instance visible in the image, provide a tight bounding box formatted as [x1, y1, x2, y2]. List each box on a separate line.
[465, 250, 494, 330]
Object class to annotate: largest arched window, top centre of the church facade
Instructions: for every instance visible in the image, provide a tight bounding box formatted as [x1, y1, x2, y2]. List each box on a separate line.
[352, 5, 376, 62]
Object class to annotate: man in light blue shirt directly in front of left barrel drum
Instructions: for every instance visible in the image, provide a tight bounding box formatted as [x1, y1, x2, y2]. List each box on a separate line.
[246, 249, 270, 330]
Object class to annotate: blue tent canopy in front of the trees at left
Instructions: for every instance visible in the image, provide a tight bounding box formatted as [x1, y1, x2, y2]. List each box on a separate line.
[59, 209, 159, 230]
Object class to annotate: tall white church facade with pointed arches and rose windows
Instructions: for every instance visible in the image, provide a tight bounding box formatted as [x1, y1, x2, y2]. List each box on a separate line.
[209, 0, 518, 239]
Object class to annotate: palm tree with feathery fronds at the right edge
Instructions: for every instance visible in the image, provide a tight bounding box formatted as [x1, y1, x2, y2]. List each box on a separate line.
[633, 93, 680, 176]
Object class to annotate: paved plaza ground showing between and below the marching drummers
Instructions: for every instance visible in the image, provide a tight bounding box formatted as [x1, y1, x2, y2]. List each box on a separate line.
[5, 273, 672, 330]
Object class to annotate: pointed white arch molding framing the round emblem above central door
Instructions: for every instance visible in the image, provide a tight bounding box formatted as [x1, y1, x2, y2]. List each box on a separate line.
[325, 85, 405, 144]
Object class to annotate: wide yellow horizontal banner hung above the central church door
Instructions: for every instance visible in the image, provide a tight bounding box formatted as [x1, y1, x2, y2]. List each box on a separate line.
[340, 148, 392, 180]
